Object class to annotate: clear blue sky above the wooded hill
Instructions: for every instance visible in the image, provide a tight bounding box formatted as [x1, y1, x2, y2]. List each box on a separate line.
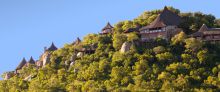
[0, 0, 220, 77]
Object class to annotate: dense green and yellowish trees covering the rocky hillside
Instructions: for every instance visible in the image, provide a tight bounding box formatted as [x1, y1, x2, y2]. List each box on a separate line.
[0, 7, 220, 92]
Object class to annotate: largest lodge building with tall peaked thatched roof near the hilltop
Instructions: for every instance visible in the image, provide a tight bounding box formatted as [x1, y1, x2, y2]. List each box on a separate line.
[139, 7, 181, 41]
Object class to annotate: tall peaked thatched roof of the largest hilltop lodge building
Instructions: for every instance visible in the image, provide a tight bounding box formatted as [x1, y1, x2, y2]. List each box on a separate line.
[140, 7, 181, 31]
